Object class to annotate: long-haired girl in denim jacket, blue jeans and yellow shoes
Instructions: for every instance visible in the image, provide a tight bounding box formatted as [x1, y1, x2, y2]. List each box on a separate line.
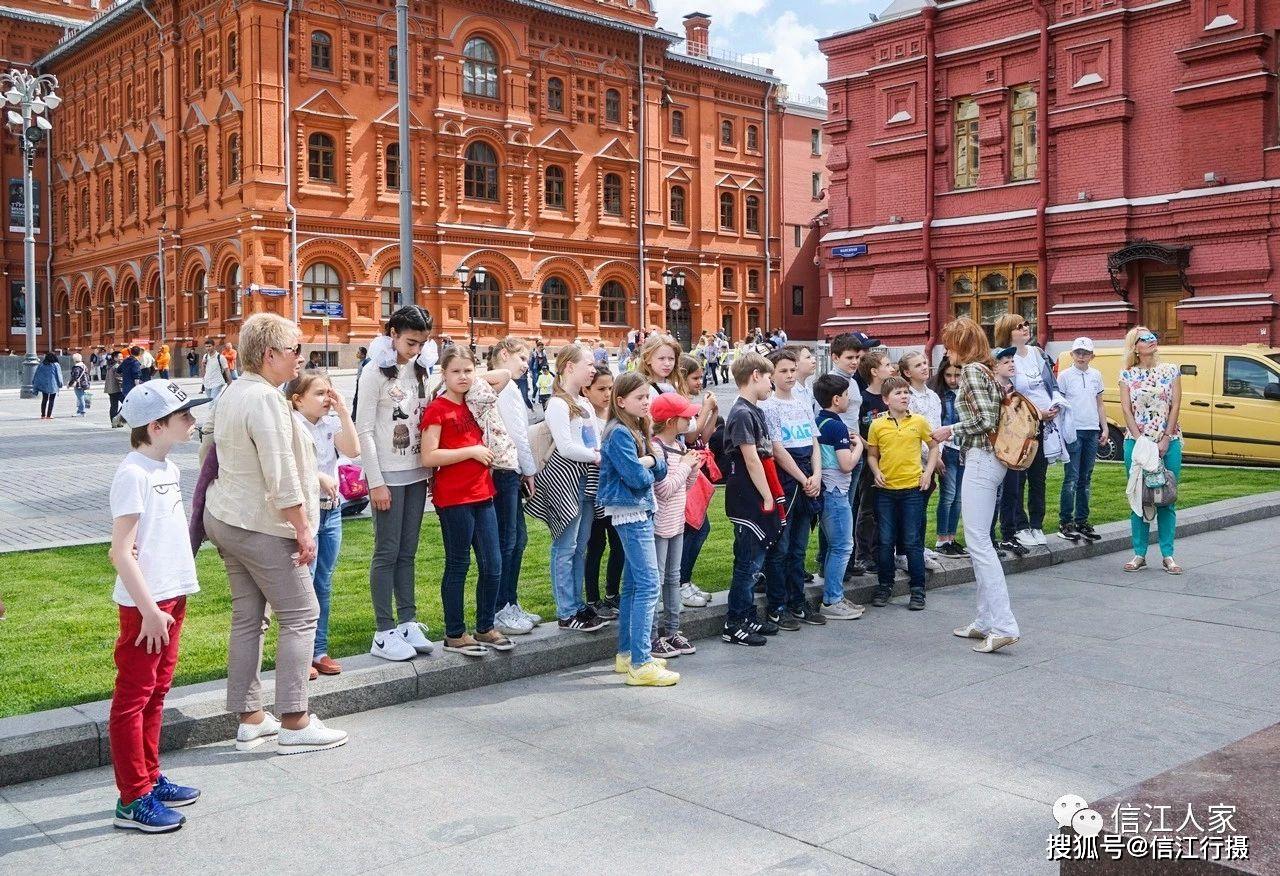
[596, 371, 680, 688]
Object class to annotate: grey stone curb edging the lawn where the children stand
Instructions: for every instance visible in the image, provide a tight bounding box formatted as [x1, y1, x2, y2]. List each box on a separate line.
[0, 492, 1280, 788]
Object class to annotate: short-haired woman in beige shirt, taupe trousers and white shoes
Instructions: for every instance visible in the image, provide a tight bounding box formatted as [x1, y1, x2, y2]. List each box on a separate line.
[204, 314, 347, 754]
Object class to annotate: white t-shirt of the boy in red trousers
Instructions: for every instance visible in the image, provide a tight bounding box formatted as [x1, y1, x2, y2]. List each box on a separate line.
[111, 451, 200, 606]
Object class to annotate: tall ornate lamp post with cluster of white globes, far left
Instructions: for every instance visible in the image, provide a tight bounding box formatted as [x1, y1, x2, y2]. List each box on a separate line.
[0, 69, 63, 398]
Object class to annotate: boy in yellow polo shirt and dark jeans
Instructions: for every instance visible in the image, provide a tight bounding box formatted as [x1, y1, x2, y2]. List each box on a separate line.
[867, 377, 941, 611]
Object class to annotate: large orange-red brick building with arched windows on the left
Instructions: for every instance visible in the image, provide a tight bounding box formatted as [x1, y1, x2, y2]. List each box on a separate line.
[5, 0, 813, 362]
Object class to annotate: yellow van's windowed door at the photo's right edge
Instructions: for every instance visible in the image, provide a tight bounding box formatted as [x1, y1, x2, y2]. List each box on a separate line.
[1213, 352, 1280, 465]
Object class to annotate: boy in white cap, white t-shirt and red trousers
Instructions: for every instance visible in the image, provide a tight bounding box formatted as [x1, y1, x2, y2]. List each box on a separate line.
[108, 379, 209, 834]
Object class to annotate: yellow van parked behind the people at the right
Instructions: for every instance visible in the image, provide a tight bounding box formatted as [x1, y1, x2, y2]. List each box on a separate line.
[1057, 343, 1280, 465]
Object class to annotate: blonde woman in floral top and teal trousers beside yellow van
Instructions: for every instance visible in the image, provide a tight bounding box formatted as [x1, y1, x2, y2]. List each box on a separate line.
[1120, 325, 1183, 575]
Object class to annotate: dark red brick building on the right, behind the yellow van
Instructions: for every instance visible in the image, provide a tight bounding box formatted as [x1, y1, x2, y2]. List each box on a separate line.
[819, 0, 1280, 350]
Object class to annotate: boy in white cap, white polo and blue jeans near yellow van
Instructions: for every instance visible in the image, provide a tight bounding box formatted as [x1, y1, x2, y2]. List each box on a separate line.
[1057, 338, 1108, 542]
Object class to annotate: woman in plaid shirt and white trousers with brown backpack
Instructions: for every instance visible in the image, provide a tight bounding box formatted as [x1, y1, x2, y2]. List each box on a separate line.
[933, 316, 1020, 654]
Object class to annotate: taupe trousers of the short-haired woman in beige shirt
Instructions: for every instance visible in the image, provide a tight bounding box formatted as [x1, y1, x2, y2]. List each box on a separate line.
[205, 511, 320, 715]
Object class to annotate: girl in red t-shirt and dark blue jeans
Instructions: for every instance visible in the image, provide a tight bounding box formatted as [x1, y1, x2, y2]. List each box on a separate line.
[422, 346, 516, 657]
